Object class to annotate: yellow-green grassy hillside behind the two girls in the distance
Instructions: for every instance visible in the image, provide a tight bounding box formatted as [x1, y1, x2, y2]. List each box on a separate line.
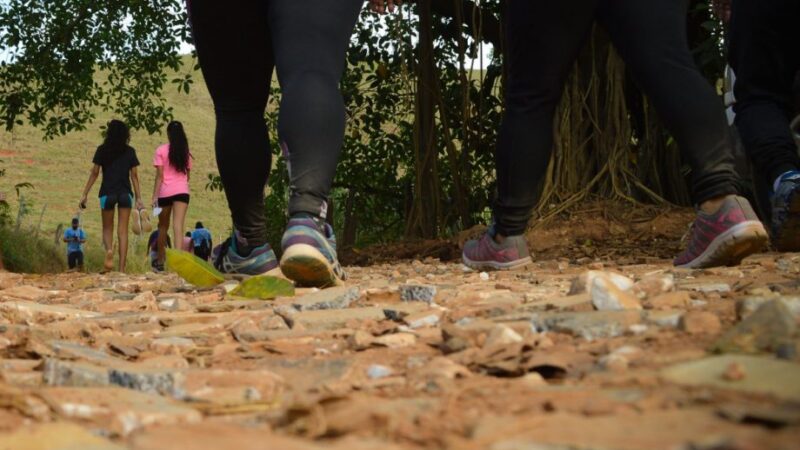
[0, 58, 230, 266]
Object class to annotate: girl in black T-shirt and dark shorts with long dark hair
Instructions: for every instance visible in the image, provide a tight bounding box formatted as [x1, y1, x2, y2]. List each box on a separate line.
[80, 120, 144, 272]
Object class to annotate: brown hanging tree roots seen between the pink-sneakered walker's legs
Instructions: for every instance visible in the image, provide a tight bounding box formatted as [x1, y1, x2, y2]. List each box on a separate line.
[531, 25, 683, 228]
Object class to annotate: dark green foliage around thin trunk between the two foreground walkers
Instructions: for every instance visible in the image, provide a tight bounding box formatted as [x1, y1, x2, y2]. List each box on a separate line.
[334, 2, 501, 245]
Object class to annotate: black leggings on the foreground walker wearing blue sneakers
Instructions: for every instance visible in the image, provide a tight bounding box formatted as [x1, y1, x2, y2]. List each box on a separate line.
[188, 0, 363, 247]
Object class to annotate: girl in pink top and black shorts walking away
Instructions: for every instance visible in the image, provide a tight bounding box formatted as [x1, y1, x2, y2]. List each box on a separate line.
[153, 121, 192, 271]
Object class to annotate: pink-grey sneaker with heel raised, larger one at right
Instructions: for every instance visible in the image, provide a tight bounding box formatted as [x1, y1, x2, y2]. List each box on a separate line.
[674, 195, 769, 269]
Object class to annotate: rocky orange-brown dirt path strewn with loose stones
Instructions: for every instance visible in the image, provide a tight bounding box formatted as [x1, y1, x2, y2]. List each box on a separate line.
[0, 254, 800, 450]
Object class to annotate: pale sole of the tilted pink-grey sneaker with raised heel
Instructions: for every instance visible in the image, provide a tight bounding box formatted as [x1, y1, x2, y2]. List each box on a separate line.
[676, 220, 769, 269]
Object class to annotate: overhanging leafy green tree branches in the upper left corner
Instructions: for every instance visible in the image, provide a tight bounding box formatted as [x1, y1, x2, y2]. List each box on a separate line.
[0, 0, 191, 138]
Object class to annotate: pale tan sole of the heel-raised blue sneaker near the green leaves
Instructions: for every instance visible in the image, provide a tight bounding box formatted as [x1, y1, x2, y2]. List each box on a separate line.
[280, 244, 341, 288]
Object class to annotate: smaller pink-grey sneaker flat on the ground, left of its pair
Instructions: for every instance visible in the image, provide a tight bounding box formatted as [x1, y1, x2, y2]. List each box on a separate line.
[461, 227, 532, 270]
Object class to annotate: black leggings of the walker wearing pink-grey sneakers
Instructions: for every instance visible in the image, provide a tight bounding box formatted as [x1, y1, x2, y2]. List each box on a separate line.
[494, 0, 738, 235]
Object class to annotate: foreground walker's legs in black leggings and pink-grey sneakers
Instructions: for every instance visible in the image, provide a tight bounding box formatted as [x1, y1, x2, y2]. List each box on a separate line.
[463, 0, 767, 269]
